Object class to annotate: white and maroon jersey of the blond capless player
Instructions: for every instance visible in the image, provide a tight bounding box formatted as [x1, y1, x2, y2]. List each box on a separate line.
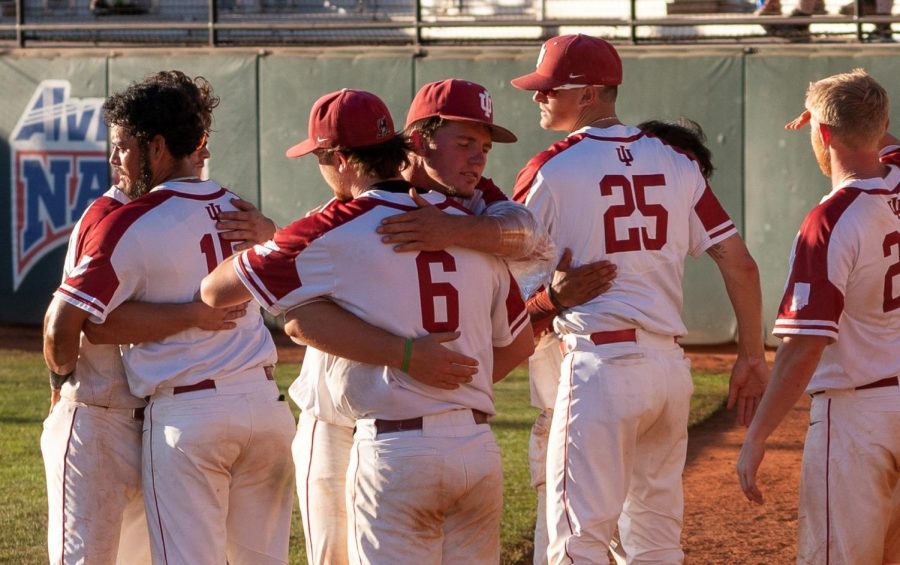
[774, 156, 900, 392]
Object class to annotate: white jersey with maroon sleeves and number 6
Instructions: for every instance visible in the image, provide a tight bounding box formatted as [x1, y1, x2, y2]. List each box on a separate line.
[235, 182, 527, 420]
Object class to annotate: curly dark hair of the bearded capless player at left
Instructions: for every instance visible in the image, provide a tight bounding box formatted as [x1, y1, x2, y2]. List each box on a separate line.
[103, 71, 219, 159]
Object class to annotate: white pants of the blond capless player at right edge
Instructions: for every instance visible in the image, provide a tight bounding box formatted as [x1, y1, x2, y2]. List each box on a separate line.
[797, 384, 900, 565]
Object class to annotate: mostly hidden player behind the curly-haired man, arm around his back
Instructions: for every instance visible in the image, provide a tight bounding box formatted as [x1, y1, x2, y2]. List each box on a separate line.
[41, 131, 267, 564]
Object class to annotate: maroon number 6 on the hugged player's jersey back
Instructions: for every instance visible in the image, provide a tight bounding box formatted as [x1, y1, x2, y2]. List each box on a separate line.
[416, 251, 459, 333]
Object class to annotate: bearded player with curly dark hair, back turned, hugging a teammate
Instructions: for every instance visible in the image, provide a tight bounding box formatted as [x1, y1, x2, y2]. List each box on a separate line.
[45, 71, 294, 564]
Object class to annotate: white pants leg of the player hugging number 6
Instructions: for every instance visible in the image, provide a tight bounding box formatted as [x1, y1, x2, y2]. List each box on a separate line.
[292, 412, 353, 565]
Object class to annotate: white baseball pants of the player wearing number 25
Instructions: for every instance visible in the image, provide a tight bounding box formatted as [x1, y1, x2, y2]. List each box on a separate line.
[547, 330, 693, 565]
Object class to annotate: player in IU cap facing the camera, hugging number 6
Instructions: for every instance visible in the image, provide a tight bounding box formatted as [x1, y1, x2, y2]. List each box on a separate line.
[256, 79, 605, 563]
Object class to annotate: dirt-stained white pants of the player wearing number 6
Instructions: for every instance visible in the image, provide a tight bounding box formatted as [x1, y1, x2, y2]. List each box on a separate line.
[347, 410, 503, 565]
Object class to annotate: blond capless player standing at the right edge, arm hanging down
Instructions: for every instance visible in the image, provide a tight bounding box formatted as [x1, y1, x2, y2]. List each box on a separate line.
[737, 69, 900, 564]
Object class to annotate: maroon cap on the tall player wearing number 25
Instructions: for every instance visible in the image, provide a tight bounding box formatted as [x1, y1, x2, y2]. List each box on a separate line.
[511, 33, 622, 90]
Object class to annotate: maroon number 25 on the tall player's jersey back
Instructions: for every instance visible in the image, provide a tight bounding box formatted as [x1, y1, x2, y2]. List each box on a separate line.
[600, 174, 669, 253]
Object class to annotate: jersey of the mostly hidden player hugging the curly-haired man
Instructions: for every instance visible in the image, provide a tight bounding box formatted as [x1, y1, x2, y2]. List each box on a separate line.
[56, 186, 146, 408]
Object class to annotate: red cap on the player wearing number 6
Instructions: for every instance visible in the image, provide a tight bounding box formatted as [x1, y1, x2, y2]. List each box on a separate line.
[285, 88, 397, 157]
